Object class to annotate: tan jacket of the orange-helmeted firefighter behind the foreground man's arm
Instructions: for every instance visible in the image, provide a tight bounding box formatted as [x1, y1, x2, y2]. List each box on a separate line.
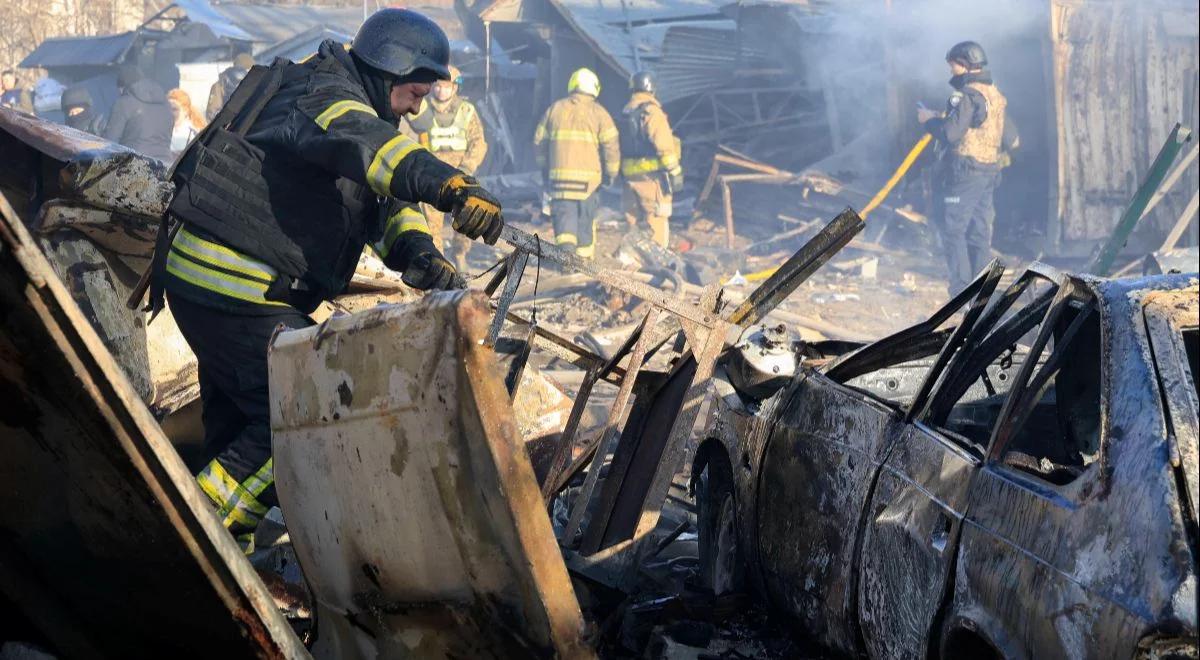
[406, 96, 487, 174]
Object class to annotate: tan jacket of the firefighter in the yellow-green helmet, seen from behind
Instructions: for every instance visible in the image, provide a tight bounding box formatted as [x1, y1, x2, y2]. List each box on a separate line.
[533, 92, 620, 200]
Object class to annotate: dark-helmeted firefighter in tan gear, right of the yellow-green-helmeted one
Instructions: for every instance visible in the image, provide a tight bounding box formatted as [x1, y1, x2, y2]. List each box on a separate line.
[620, 71, 683, 247]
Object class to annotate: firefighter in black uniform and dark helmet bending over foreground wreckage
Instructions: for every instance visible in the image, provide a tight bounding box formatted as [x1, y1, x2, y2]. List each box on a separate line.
[150, 8, 504, 541]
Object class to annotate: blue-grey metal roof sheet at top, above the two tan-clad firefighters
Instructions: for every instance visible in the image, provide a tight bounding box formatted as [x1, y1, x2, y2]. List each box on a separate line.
[550, 0, 733, 76]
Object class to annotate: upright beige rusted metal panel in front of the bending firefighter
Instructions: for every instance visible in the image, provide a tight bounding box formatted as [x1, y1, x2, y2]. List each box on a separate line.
[270, 292, 593, 658]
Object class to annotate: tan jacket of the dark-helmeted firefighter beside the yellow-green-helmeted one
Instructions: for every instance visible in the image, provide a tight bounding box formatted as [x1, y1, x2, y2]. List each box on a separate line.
[620, 91, 682, 181]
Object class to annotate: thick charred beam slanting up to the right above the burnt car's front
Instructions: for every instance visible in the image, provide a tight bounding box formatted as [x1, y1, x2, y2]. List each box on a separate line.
[727, 206, 864, 328]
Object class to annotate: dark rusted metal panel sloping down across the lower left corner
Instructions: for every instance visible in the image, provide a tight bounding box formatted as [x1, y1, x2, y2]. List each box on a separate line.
[0, 189, 307, 658]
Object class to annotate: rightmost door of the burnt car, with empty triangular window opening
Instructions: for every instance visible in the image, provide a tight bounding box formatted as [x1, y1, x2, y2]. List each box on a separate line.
[938, 272, 1147, 658]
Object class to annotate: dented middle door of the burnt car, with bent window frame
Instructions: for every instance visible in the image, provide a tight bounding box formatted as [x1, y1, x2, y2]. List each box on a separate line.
[858, 266, 1052, 658]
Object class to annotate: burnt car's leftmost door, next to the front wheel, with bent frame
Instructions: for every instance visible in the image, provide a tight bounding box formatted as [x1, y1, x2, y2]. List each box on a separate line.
[756, 262, 1003, 653]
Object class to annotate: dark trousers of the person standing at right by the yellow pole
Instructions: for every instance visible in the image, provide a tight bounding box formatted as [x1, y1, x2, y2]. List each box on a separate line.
[941, 158, 1000, 295]
